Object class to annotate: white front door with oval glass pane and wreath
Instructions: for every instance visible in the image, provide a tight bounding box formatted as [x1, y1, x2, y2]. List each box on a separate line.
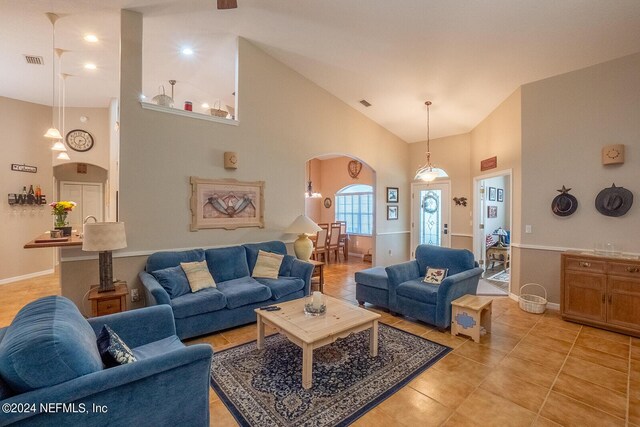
[411, 182, 451, 258]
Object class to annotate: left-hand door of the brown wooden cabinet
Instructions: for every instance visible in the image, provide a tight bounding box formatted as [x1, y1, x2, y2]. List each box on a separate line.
[562, 271, 607, 322]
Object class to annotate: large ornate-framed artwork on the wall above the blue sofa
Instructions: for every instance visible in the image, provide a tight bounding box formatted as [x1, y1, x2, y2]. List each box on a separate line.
[191, 176, 264, 231]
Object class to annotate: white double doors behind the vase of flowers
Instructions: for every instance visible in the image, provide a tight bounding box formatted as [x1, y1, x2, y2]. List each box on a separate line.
[60, 181, 104, 230]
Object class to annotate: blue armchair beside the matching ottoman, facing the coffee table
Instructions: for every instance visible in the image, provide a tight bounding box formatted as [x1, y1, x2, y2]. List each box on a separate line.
[386, 245, 482, 329]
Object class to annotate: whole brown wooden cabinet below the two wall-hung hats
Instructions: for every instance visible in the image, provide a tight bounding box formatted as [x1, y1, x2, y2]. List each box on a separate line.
[560, 251, 640, 336]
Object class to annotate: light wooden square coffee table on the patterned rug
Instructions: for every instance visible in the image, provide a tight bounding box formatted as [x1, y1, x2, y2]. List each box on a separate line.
[255, 295, 380, 389]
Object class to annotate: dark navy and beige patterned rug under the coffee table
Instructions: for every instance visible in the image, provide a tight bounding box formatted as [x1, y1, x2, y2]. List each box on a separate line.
[211, 324, 451, 427]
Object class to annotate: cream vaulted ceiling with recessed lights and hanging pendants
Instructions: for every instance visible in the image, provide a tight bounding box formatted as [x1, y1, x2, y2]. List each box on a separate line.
[0, 0, 640, 142]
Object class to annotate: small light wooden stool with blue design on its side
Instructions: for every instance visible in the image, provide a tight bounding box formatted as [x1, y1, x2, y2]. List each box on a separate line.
[451, 295, 493, 343]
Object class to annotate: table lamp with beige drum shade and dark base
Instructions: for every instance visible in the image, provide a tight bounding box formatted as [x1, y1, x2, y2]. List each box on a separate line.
[82, 222, 127, 292]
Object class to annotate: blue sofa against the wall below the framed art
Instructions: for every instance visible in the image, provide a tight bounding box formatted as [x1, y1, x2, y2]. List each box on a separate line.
[139, 241, 313, 339]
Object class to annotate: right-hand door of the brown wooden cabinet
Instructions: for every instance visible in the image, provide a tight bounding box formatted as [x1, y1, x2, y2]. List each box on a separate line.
[607, 276, 640, 330]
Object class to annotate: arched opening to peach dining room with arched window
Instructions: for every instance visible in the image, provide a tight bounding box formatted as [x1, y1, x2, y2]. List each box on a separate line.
[304, 154, 376, 262]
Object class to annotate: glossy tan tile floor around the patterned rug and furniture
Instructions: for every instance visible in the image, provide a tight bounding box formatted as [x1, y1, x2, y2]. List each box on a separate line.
[0, 257, 640, 426]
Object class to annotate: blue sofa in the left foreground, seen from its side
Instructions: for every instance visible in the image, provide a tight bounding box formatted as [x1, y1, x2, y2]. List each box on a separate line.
[0, 296, 213, 426]
